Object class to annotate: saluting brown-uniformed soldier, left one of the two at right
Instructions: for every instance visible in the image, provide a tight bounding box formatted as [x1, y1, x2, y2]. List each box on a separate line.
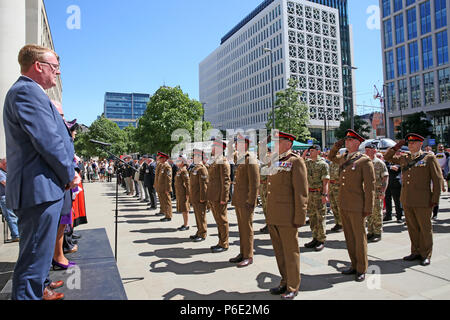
[328, 129, 375, 282]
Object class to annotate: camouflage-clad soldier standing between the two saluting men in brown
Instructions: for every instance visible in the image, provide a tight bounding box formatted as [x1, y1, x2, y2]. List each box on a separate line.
[366, 143, 389, 242]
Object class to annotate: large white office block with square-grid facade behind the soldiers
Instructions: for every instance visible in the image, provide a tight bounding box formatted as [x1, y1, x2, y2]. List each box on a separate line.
[199, 0, 352, 146]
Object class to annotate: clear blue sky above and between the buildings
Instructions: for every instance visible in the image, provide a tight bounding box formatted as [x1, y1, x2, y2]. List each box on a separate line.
[44, 0, 383, 125]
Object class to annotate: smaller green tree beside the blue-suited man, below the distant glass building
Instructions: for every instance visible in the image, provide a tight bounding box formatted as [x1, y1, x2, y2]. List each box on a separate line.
[75, 115, 128, 158]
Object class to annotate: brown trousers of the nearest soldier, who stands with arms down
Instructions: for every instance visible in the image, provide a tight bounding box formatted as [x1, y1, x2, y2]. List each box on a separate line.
[269, 225, 300, 291]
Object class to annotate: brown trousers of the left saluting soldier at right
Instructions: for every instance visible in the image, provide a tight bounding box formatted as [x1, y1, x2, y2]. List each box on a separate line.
[340, 208, 369, 273]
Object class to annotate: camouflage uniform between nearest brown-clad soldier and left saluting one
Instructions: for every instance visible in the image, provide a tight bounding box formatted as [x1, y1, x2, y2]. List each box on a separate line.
[306, 157, 330, 242]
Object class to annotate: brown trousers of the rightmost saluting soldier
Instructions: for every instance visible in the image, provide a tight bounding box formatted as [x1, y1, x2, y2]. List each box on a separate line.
[404, 207, 433, 259]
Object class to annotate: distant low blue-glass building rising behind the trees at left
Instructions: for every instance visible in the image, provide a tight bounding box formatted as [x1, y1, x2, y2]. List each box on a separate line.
[104, 92, 150, 129]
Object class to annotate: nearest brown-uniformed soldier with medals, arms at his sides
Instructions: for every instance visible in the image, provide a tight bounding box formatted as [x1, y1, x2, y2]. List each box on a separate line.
[267, 132, 308, 300]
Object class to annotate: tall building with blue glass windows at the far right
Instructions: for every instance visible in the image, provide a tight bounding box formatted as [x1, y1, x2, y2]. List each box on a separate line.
[380, 0, 450, 145]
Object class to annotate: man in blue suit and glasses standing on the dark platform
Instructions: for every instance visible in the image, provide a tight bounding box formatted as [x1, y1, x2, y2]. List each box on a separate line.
[3, 45, 80, 300]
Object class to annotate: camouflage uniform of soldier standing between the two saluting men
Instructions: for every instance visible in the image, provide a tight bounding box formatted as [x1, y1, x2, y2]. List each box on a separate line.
[367, 157, 389, 235]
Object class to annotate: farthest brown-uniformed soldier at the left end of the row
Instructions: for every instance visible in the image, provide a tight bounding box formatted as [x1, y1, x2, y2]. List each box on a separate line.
[155, 152, 172, 222]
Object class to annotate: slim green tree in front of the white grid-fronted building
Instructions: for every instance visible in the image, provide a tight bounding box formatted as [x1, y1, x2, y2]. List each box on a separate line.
[266, 78, 311, 142]
